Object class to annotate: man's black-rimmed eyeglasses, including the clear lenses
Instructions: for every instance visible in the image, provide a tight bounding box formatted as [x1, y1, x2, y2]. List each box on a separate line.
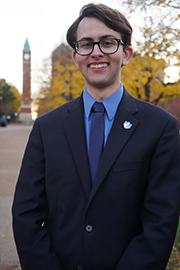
[74, 38, 124, 55]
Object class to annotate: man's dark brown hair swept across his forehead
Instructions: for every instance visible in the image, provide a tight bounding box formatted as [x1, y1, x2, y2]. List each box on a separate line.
[66, 3, 133, 49]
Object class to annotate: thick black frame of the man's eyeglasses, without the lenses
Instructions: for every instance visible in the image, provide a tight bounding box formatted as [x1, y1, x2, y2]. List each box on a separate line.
[73, 38, 124, 56]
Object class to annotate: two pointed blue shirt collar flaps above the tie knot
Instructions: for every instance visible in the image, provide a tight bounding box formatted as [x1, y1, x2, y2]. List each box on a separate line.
[83, 83, 123, 121]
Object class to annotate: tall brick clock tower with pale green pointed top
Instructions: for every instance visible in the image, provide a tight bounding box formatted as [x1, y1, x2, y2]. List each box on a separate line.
[20, 39, 32, 124]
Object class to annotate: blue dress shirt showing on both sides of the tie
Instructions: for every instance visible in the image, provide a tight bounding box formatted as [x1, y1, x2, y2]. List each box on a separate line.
[83, 83, 123, 153]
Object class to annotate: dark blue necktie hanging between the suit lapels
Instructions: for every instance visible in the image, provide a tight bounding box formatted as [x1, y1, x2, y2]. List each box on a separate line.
[89, 102, 104, 183]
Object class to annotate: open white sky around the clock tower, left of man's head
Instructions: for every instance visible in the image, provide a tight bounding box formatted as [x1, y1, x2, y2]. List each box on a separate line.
[0, 0, 129, 93]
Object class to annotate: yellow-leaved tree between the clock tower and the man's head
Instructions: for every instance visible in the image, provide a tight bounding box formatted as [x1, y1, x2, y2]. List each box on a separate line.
[34, 50, 84, 116]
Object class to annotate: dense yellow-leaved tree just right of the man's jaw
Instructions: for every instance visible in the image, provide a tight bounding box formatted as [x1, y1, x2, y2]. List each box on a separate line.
[122, 53, 180, 105]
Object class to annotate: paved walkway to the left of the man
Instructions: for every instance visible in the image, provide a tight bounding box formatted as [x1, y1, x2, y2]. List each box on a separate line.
[0, 124, 32, 270]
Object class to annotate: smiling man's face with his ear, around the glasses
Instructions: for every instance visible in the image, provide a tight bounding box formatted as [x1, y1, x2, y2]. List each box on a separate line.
[73, 17, 132, 97]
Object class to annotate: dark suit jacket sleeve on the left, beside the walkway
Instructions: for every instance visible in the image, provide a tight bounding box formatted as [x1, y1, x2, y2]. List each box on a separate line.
[12, 120, 63, 270]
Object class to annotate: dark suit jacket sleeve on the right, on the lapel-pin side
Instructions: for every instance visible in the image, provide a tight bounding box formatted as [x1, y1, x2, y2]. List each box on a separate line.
[116, 118, 180, 270]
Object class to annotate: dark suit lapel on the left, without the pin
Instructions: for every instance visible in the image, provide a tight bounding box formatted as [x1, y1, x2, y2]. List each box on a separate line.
[63, 96, 91, 198]
